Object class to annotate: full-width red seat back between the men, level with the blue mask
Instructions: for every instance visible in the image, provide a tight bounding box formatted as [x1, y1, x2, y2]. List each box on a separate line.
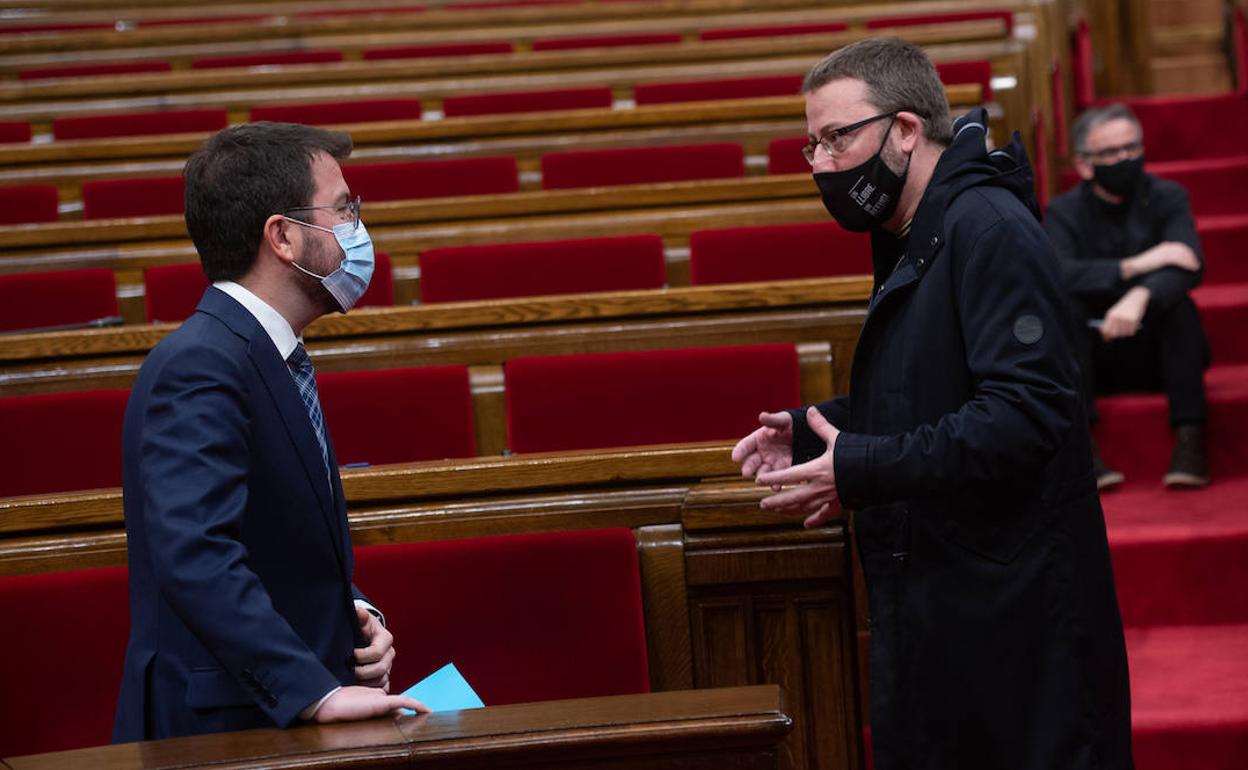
[421, 235, 666, 302]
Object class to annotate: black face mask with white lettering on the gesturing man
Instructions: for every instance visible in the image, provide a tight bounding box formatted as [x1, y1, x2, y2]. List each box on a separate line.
[815, 119, 910, 232]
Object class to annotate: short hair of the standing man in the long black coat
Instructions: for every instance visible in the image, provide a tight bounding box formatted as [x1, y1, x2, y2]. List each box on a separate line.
[801, 37, 953, 146]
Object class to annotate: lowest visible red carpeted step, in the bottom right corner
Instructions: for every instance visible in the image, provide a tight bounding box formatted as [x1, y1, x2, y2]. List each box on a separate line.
[1127, 623, 1248, 770]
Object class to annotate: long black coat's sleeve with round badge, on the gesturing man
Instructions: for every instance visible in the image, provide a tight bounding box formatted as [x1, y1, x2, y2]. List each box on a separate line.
[834, 209, 1078, 508]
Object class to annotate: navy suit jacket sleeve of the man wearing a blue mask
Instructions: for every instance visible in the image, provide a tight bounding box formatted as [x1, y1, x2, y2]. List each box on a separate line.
[139, 346, 339, 726]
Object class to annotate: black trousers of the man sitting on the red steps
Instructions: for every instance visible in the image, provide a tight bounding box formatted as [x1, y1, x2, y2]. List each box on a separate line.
[1072, 297, 1209, 426]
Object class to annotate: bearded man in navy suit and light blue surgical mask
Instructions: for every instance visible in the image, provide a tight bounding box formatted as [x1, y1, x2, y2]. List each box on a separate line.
[114, 124, 423, 741]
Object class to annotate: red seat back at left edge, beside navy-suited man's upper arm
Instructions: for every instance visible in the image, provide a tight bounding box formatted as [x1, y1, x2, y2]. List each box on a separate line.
[0, 389, 130, 496]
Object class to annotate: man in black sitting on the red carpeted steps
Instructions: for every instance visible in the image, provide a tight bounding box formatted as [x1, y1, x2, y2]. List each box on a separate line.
[1045, 104, 1209, 489]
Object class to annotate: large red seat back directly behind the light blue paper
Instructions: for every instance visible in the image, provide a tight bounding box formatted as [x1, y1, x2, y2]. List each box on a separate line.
[346, 529, 650, 706]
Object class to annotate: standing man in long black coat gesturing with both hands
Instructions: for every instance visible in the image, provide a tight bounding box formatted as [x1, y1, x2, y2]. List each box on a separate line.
[733, 39, 1133, 770]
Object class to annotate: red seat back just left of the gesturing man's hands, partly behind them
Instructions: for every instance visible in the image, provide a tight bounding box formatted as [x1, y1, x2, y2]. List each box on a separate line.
[504, 344, 800, 452]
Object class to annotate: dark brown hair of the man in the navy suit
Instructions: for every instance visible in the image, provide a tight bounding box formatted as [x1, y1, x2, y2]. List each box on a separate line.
[182, 121, 351, 281]
